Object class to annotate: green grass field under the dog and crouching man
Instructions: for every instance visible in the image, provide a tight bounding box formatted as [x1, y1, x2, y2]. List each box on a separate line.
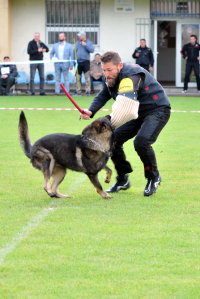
[0, 96, 200, 299]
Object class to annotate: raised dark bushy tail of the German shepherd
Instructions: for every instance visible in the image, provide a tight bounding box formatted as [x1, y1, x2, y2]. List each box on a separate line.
[18, 111, 32, 159]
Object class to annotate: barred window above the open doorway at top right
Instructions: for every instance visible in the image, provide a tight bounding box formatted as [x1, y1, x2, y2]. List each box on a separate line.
[151, 0, 200, 19]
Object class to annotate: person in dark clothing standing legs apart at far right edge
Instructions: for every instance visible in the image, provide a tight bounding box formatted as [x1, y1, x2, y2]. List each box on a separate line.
[181, 35, 200, 93]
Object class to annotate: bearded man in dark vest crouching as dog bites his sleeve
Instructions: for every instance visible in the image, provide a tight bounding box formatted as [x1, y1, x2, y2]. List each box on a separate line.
[81, 51, 171, 196]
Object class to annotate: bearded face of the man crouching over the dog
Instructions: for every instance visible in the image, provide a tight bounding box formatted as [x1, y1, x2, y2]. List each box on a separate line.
[102, 61, 123, 87]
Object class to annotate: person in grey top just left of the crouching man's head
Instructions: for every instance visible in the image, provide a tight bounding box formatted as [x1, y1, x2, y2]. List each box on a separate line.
[90, 53, 103, 94]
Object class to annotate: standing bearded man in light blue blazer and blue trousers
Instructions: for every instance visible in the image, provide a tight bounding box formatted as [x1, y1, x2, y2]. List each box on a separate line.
[50, 32, 74, 96]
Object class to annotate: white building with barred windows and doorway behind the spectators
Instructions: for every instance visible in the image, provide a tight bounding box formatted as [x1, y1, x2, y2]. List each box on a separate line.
[0, 0, 200, 87]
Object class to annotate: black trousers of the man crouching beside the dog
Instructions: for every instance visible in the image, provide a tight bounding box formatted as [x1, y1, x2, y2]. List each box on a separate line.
[111, 105, 170, 179]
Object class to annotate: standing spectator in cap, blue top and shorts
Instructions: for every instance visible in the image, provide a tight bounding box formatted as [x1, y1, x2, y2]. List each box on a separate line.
[74, 31, 94, 96]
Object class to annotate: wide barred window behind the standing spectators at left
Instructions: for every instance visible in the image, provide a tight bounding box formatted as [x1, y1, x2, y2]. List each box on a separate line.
[46, 0, 100, 47]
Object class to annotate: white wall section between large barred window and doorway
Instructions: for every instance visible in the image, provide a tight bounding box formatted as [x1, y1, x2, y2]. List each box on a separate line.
[100, 0, 150, 63]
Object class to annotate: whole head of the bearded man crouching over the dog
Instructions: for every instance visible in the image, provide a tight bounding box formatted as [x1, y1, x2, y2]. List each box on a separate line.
[100, 51, 123, 87]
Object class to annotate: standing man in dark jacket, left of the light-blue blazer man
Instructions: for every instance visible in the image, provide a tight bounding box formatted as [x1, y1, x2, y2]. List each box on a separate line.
[28, 32, 49, 96]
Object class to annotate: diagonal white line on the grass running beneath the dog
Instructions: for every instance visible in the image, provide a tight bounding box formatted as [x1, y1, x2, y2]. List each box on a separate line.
[0, 173, 86, 265]
